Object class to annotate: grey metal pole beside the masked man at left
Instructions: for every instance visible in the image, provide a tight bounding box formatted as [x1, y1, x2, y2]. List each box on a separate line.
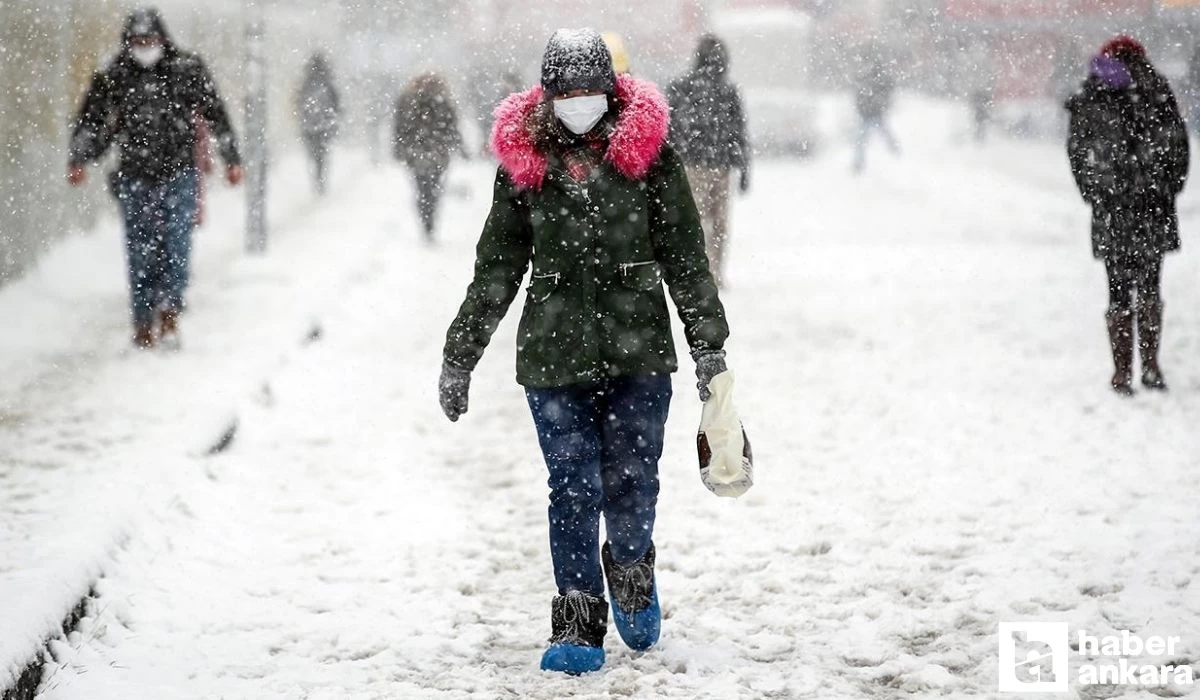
[246, 4, 269, 255]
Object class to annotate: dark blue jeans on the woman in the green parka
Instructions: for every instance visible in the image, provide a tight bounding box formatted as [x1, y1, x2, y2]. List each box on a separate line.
[526, 375, 671, 596]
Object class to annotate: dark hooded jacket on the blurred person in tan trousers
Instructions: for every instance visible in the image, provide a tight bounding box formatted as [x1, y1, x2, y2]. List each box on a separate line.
[667, 36, 750, 169]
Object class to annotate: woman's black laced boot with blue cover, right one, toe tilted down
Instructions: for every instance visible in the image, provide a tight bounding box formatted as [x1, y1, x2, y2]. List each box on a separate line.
[600, 543, 662, 651]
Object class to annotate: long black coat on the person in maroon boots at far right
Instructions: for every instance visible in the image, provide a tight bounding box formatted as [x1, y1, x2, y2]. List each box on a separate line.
[1067, 60, 1189, 258]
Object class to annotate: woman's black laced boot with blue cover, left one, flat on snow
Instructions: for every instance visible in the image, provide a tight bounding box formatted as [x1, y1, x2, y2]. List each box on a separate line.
[541, 591, 608, 676]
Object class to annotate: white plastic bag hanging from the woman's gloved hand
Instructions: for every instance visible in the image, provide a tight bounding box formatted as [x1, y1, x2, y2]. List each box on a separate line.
[696, 371, 754, 498]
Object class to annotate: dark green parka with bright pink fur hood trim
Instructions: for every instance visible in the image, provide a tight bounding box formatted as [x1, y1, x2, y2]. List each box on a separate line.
[444, 76, 728, 388]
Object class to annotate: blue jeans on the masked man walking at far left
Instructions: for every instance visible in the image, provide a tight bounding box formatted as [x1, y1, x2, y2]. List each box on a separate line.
[114, 170, 199, 325]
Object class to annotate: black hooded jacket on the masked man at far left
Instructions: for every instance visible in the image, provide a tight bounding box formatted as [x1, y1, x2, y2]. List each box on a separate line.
[68, 11, 241, 183]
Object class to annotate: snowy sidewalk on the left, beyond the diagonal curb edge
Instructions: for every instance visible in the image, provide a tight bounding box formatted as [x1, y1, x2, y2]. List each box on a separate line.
[0, 154, 456, 688]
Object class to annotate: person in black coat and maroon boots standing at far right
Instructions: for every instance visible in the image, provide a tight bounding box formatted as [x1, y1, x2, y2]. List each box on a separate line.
[1067, 36, 1189, 395]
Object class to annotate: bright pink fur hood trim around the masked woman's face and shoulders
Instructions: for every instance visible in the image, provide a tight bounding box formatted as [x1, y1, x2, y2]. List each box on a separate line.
[492, 76, 671, 190]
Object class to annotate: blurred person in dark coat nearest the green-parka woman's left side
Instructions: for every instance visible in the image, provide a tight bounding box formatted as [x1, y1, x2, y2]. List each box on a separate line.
[392, 73, 464, 241]
